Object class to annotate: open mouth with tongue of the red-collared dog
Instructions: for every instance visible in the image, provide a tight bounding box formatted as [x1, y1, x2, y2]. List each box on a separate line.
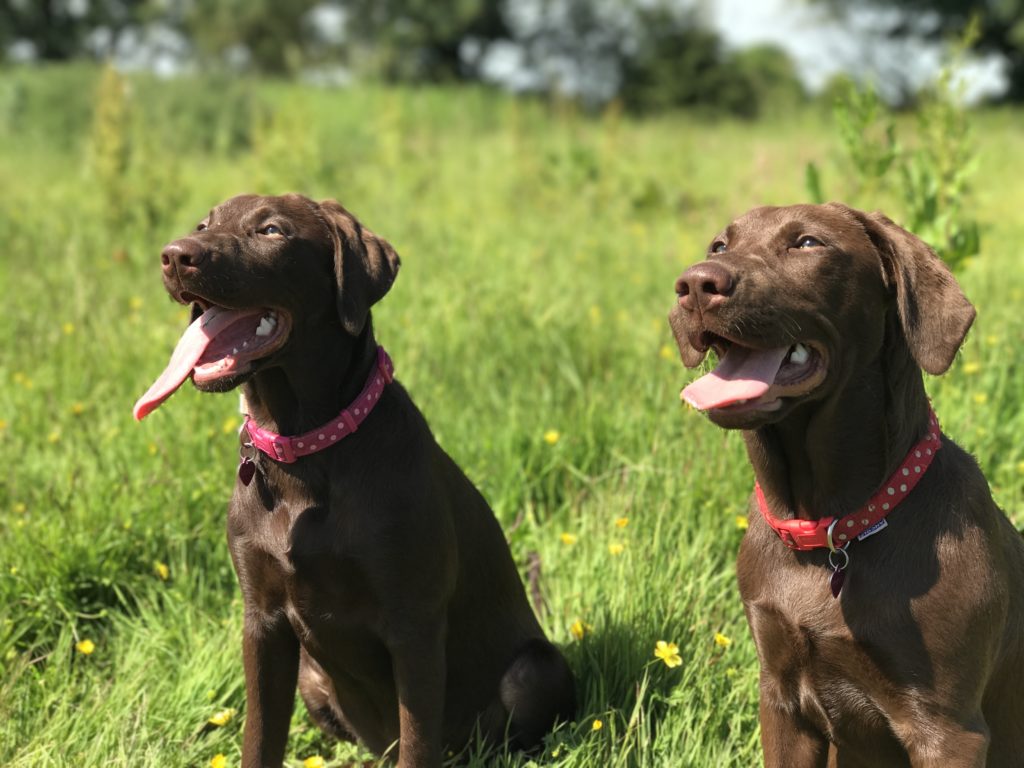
[680, 337, 827, 413]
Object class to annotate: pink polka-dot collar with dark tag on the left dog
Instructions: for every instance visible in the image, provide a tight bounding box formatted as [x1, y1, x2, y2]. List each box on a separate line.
[239, 347, 394, 485]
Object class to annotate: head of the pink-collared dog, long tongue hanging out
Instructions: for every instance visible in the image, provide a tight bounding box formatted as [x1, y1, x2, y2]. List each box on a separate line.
[135, 195, 399, 418]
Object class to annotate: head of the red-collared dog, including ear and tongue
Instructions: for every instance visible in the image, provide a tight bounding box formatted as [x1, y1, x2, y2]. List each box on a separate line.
[669, 203, 975, 429]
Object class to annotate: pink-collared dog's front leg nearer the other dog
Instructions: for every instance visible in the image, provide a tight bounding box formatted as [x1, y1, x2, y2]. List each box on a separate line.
[388, 617, 446, 768]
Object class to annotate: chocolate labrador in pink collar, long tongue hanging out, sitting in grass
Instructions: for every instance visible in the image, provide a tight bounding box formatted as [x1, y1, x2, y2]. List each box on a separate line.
[135, 195, 574, 768]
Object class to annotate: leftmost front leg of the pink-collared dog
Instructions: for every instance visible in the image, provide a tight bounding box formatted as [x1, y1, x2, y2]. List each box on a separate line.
[242, 612, 299, 768]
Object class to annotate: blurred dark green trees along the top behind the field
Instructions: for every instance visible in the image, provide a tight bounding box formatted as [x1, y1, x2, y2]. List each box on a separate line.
[0, 0, 1024, 117]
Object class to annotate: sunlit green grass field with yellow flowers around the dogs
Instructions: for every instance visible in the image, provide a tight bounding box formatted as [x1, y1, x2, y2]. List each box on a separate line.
[0, 70, 1024, 768]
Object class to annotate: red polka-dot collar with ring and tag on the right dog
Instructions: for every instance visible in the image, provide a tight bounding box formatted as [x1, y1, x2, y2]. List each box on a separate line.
[754, 407, 942, 596]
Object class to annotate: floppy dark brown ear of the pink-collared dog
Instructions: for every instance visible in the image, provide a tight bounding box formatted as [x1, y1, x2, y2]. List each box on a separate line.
[319, 200, 401, 336]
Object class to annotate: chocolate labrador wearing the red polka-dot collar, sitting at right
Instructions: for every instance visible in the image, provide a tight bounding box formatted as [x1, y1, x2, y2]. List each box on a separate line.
[670, 204, 1024, 768]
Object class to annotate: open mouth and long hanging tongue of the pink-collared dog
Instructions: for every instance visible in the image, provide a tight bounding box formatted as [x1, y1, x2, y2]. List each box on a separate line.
[132, 296, 291, 419]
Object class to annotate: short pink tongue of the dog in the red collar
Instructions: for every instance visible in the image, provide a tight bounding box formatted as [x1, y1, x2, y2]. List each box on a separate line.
[682, 344, 790, 411]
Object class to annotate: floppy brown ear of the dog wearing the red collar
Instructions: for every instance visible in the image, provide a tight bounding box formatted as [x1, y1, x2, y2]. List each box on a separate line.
[854, 211, 975, 376]
